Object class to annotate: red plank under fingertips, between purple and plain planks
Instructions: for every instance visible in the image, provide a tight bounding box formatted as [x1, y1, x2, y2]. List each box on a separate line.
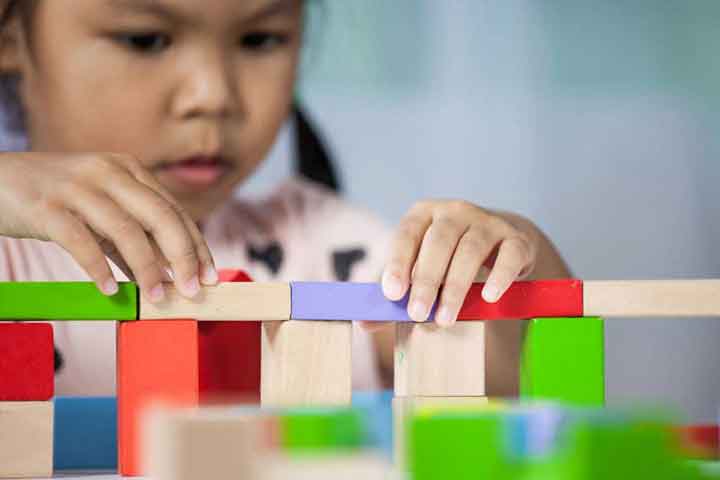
[458, 280, 583, 320]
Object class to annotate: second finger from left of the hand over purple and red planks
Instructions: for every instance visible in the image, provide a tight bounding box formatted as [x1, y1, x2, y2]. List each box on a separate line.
[408, 217, 466, 322]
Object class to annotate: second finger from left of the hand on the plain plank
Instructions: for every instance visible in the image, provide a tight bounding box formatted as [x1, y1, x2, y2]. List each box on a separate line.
[66, 189, 165, 302]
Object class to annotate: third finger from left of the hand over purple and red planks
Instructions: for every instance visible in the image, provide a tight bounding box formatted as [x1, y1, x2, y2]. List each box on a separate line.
[435, 227, 500, 327]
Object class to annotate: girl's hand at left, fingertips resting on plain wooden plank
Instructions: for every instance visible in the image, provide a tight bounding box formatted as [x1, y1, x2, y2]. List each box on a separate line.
[0, 152, 218, 302]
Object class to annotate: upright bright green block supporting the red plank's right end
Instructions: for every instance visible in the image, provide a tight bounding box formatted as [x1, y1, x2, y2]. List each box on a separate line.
[520, 317, 605, 406]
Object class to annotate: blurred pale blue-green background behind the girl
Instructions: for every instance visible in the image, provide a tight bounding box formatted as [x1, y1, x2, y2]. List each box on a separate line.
[243, 0, 720, 421]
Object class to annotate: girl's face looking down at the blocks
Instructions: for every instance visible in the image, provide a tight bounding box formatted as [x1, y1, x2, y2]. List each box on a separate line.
[11, 0, 303, 219]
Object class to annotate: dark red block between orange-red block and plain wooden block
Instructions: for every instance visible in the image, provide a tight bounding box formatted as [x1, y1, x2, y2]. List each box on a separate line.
[198, 270, 260, 404]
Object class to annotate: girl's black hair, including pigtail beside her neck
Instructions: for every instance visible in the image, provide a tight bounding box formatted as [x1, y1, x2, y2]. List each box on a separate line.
[0, 0, 341, 192]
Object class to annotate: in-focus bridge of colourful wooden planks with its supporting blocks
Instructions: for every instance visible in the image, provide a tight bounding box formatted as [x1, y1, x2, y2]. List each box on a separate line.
[0, 272, 720, 476]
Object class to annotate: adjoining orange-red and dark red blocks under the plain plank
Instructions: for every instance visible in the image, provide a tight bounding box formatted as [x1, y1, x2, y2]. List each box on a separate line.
[117, 271, 264, 476]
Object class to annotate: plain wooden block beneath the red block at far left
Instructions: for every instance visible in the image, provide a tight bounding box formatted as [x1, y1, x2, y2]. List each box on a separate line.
[0, 402, 53, 478]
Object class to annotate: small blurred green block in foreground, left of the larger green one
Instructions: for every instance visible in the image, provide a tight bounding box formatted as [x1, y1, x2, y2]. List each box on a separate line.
[280, 408, 367, 453]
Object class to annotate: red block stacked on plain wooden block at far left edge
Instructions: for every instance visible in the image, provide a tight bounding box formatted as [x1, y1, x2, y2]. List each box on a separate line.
[0, 322, 54, 477]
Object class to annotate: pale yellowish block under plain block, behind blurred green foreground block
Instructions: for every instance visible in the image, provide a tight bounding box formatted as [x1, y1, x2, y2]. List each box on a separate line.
[392, 397, 490, 472]
